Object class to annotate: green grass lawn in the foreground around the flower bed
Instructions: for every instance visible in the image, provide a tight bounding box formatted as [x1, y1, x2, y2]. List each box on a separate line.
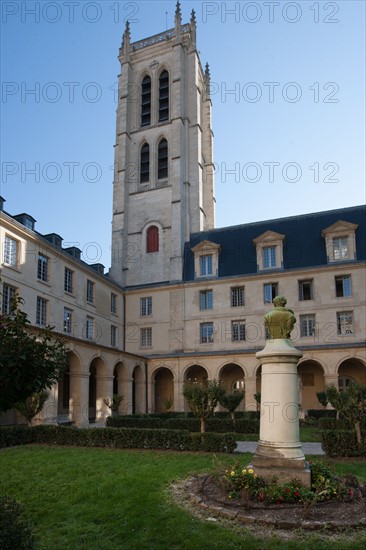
[0, 446, 366, 550]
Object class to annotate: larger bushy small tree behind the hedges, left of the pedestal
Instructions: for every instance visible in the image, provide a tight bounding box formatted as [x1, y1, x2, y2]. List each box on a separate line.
[183, 380, 225, 433]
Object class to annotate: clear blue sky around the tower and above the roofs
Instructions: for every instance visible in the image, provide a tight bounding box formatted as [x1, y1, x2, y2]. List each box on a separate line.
[0, 0, 365, 268]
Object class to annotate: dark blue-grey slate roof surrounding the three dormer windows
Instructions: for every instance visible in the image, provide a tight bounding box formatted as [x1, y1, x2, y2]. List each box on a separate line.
[183, 205, 366, 281]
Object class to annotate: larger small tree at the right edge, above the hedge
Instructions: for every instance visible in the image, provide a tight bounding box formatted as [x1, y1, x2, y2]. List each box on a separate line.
[325, 380, 366, 445]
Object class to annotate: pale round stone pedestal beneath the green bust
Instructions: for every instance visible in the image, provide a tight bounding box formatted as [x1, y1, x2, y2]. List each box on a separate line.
[251, 338, 311, 486]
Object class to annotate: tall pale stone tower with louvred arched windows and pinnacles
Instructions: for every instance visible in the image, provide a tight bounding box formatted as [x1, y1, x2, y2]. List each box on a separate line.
[110, 2, 214, 286]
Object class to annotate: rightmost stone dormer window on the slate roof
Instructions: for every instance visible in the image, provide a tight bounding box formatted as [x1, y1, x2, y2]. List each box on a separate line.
[322, 220, 358, 263]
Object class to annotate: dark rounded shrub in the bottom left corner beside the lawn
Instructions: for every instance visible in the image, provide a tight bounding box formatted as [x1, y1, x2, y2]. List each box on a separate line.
[0, 495, 35, 550]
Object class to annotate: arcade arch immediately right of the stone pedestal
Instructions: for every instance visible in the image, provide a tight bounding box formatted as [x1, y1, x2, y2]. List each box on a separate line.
[297, 359, 325, 413]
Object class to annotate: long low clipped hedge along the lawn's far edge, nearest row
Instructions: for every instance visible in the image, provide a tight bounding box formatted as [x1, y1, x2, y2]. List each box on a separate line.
[0, 426, 236, 453]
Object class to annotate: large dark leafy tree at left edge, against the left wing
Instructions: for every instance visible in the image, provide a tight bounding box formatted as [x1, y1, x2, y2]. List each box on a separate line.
[0, 296, 67, 411]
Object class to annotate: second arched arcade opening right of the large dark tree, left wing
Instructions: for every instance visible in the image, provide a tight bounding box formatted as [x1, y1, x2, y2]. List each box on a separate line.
[88, 357, 109, 424]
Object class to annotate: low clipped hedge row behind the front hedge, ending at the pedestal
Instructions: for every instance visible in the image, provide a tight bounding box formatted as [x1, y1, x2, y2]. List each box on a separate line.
[106, 416, 259, 434]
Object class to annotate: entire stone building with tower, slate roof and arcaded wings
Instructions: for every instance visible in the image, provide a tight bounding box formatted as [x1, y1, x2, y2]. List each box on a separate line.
[0, 2, 366, 425]
